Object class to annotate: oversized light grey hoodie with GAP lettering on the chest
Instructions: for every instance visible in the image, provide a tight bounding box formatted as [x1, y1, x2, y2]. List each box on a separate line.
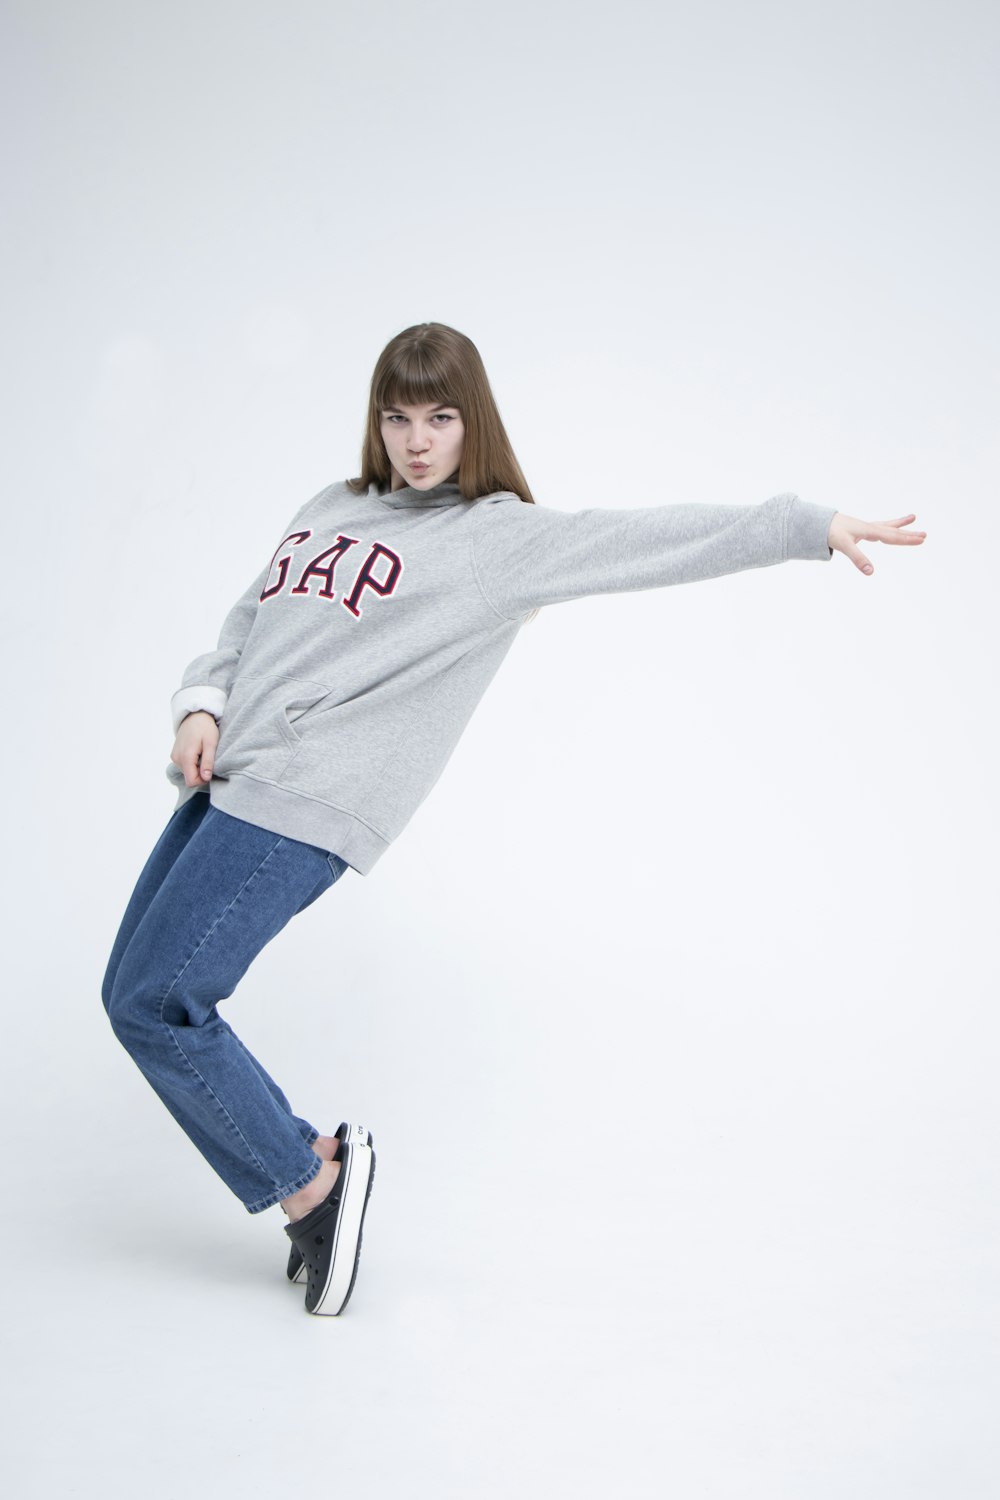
[166, 480, 837, 875]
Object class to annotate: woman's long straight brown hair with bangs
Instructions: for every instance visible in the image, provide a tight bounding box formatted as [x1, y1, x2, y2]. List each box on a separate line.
[348, 323, 535, 506]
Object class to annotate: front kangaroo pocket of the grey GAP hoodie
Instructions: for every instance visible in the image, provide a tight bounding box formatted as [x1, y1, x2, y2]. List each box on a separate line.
[214, 677, 330, 779]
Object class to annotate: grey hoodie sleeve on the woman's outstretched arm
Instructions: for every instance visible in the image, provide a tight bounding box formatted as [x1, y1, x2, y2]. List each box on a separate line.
[472, 492, 837, 620]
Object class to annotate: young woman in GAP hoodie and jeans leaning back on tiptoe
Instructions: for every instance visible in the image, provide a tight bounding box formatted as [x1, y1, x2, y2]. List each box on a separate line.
[103, 323, 925, 1316]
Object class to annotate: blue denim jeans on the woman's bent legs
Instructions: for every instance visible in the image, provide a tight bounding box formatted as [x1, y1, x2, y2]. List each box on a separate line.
[102, 792, 349, 1214]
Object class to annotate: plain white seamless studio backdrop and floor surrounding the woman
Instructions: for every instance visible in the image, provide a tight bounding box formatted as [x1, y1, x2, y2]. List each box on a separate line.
[1, 0, 1000, 1500]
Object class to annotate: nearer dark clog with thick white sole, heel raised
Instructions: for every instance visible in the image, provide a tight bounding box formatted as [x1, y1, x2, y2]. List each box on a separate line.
[285, 1136, 375, 1317]
